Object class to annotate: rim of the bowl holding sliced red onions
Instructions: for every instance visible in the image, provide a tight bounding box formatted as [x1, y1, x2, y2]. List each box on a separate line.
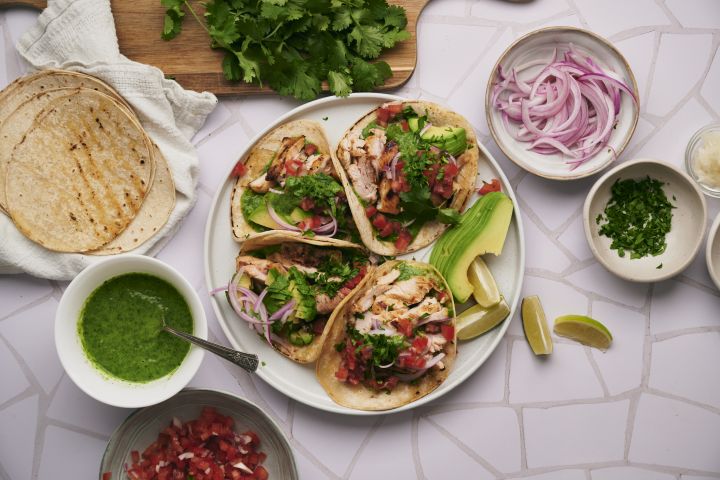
[485, 25, 640, 181]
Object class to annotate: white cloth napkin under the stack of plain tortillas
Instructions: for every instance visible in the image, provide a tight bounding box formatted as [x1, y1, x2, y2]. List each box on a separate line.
[0, 0, 217, 280]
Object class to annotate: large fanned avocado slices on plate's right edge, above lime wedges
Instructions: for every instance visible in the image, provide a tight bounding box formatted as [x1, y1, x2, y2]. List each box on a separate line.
[430, 192, 513, 303]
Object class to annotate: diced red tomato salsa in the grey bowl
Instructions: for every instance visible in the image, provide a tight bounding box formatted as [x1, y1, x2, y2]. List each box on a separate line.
[125, 407, 268, 480]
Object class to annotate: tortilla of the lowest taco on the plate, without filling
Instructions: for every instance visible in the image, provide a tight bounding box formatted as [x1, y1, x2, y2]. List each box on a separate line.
[315, 260, 457, 411]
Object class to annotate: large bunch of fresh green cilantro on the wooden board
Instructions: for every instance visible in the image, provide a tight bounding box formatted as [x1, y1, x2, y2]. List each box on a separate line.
[161, 0, 410, 100]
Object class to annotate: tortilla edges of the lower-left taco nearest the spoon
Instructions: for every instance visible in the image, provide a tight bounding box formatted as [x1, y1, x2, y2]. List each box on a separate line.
[238, 231, 373, 363]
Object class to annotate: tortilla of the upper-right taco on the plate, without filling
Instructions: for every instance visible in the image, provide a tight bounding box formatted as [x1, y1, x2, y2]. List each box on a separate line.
[335, 101, 480, 256]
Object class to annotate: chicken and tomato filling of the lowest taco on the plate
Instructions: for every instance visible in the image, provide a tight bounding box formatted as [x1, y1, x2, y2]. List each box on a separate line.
[335, 262, 455, 392]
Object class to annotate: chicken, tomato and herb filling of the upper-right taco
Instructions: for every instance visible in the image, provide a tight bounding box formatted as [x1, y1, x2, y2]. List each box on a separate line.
[338, 102, 469, 251]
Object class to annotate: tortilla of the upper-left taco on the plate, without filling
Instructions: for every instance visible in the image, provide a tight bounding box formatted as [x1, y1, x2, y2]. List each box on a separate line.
[230, 120, 337, 242]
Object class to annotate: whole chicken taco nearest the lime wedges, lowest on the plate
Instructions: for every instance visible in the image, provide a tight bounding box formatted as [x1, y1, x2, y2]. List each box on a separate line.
[316, 261, 456, 410]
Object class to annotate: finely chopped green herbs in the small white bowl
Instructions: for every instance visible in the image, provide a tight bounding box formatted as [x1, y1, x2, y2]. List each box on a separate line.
[595, 177, 675, 258]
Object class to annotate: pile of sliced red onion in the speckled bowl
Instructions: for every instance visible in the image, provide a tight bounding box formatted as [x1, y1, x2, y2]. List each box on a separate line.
[491, 44, 637, 169]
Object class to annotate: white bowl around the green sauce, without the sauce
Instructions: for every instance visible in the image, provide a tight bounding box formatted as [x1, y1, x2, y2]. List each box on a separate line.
[54, 253, 208, 408]
